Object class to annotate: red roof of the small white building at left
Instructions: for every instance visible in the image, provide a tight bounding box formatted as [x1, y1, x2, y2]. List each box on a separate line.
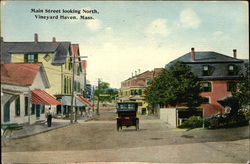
[1, 63, 49, 86]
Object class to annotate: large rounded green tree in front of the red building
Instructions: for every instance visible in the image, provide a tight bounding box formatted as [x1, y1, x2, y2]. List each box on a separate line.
[145, 62, 202, 108]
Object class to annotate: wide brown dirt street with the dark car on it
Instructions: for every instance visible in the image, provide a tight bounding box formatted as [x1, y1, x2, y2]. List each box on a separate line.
[2, 107, 249, 163]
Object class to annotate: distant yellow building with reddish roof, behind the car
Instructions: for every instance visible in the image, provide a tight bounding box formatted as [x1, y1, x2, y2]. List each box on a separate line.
[117, 68, 163, 115]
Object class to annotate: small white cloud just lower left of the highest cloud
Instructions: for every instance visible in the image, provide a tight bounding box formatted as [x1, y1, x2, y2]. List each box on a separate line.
[146, 18, 170, 36]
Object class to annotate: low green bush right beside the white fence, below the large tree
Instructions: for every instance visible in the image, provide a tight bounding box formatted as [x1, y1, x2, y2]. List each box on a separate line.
[179, 116, 203, 129]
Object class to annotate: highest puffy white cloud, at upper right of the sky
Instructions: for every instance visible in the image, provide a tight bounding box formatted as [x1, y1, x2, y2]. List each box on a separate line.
[180, 8, 201, 29]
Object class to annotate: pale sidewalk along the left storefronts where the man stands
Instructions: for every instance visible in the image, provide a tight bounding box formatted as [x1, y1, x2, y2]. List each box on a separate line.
[11, 117, 94, 139]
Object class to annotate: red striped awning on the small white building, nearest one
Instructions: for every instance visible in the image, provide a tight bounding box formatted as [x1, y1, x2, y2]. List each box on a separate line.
[31, 89, 62, 105]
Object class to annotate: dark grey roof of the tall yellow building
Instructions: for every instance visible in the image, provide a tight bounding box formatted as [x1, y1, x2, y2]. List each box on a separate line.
[1, 42, 71, 64]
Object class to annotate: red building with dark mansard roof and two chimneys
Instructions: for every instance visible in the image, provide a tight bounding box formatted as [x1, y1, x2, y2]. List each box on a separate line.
[165, 48, 245, 116]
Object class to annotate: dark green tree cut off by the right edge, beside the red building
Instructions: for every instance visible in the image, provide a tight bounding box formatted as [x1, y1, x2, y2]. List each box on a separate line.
[232, 63, 250, 107]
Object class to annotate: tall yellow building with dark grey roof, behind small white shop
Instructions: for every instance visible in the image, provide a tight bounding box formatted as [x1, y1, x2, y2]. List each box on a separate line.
[1, 34, 89, 117]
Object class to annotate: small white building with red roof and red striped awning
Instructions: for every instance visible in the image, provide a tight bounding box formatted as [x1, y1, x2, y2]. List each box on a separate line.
[1, 63, 61, 124]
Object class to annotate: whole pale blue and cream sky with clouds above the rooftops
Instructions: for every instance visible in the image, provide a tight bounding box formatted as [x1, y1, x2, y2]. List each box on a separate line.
[1, 1, 249, 88]
